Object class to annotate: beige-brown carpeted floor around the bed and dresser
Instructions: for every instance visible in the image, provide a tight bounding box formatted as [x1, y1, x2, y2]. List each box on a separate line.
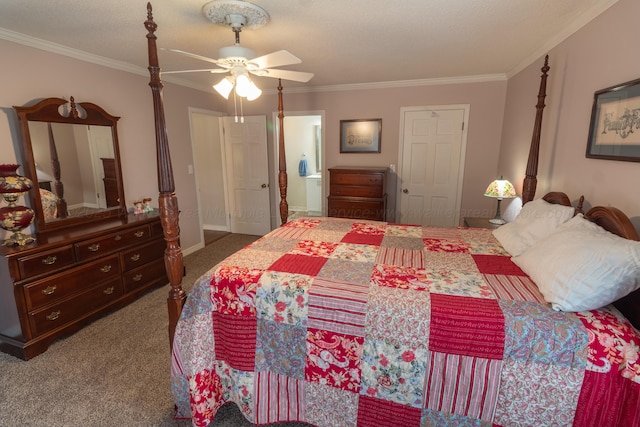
[0, 234, 306, 427]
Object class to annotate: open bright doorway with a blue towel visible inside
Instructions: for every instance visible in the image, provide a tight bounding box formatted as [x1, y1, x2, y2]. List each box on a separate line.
[274, 112, 325, 220]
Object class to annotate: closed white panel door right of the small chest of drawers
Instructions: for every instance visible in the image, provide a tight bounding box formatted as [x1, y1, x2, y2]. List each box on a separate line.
[398, 106, 468, 227]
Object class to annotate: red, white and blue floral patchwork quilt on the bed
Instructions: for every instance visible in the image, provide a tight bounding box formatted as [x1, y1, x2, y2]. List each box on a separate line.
[172, 218, 640, 427]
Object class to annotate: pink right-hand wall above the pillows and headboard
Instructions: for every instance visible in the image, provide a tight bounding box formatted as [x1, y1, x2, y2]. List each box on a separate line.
[499, 0, 640, 228]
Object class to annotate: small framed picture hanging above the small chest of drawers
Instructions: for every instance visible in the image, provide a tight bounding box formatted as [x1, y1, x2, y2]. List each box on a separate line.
[340, 119, 382, 153]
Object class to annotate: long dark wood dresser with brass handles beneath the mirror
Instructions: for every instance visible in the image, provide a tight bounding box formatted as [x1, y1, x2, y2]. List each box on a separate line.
[0, 214, 168, 359]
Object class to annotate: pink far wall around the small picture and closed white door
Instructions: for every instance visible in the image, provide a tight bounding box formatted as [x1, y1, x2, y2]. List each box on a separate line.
[244, 80, 508, 224]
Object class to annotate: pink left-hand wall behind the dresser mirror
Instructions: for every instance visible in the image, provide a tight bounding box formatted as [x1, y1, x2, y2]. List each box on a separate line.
[0, 40, 225, 248]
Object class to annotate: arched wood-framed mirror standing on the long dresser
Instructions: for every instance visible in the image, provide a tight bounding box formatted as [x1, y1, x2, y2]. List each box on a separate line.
[14, 97, 126, 233]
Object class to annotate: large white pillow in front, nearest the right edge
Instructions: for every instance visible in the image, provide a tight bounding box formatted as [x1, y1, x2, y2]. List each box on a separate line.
[512, 214, 640, 311]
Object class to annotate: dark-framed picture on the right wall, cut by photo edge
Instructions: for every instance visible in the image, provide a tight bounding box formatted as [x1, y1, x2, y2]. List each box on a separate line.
[586, 79, 640, 162]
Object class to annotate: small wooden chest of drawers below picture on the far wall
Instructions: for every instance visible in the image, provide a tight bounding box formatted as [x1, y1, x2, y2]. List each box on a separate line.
[327, 167, 387, 221]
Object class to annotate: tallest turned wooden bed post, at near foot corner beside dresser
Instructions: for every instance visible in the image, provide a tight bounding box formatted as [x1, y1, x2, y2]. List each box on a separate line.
[144, 3, 186, 346]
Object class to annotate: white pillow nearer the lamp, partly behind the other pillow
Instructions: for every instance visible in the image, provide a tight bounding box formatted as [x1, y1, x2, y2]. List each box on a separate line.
[493, 199, 575, 256]
